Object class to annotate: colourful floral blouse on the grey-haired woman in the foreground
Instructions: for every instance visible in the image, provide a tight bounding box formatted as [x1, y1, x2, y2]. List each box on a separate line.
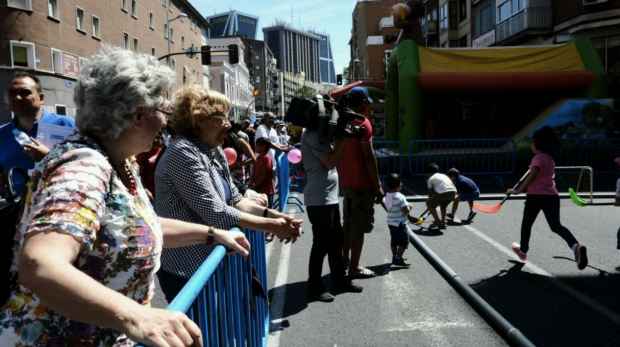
[0, 134, 163, 347]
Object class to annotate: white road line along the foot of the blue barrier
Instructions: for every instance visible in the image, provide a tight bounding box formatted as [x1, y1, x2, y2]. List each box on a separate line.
[267, 207, 297, 347]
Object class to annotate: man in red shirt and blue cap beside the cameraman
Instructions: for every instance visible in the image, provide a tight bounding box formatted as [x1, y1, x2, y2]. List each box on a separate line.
[338, 87, 385, 278]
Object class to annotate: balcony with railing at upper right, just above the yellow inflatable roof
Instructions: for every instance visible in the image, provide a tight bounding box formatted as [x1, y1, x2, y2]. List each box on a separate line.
[495, 7, 553, 42]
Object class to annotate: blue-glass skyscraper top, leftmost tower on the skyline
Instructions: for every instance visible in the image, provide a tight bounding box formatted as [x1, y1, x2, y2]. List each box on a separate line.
[206, 11, 258, 40]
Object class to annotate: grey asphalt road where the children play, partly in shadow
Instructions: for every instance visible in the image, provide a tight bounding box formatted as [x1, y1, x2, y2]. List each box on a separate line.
[268, 193, 620, 347]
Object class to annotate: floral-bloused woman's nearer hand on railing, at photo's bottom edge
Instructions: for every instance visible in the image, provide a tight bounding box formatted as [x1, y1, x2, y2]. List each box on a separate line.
[123, 307, 202, 347]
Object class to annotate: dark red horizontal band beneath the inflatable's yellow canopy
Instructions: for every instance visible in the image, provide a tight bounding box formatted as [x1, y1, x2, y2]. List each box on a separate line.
[420, 71, 594, 91]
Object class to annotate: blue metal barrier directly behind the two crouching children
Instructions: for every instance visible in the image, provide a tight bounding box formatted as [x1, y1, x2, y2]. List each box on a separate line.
[409, 138, 517, 186]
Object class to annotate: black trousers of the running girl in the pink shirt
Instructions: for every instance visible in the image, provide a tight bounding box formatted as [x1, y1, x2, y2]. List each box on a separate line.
[521, 195, 578, 253]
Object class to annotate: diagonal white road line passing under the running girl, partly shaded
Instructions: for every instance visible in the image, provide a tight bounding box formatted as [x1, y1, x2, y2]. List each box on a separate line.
[455, 218, 620, 325]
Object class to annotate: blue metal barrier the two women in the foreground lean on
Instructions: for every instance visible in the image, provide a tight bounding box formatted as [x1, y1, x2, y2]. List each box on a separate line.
[139, 228, 269, 347]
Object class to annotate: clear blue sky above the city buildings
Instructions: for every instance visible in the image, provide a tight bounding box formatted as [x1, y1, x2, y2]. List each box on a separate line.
[190, 0, 357, 74]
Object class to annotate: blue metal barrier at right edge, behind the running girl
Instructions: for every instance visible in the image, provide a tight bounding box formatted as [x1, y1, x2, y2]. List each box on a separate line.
[552, 138, 620, 173]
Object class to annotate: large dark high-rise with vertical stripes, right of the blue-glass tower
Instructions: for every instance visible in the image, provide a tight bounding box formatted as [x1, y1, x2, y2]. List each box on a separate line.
[263, 24, 321, 83]
